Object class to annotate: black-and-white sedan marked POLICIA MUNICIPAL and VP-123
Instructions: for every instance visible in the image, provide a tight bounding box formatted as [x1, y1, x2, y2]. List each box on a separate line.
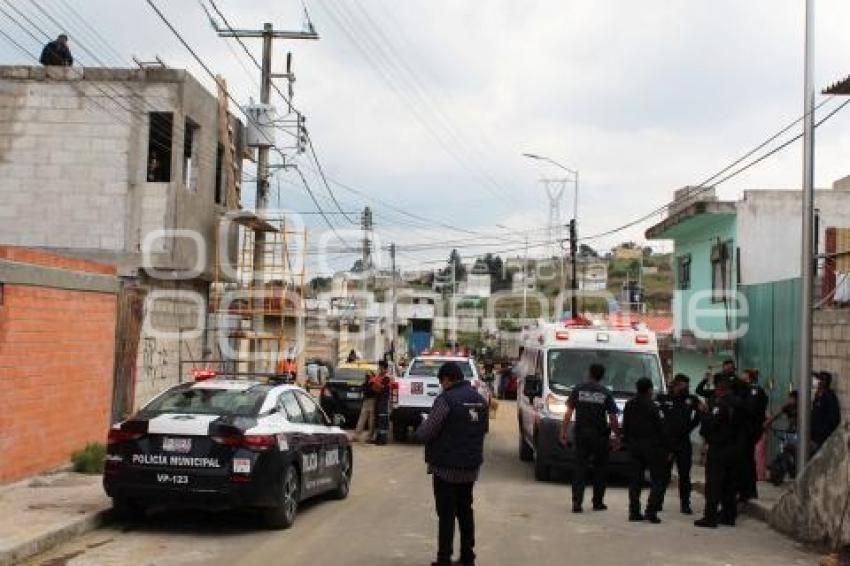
[103, 375, 353, 528]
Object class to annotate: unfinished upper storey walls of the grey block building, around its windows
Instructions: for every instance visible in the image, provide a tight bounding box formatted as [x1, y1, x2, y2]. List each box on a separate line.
[0, 66, 239, 277]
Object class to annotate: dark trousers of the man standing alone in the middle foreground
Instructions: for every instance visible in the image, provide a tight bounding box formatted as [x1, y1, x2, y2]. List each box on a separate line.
[434, 476, 475, 564]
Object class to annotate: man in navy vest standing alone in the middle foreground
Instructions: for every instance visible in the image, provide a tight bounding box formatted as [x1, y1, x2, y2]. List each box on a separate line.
[416, 362, 490, 566]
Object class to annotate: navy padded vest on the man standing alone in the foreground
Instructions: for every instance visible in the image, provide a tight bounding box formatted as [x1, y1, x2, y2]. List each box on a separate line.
[425, 381, 489, 470]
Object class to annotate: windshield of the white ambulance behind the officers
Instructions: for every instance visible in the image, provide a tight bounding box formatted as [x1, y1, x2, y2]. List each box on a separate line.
[549, 349, 661, 395]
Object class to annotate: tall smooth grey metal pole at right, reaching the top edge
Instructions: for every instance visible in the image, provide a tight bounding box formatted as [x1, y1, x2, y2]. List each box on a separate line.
[797, 0, 815, 480]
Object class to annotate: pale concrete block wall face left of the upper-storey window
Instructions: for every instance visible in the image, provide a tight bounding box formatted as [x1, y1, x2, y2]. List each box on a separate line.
[0, 74, 137, 250]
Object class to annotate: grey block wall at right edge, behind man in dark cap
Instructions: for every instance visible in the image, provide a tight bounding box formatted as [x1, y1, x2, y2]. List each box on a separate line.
[812, 309, 850, 422]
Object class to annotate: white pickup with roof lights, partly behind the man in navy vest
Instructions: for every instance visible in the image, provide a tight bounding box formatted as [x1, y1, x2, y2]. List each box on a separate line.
[390, 350, 490, 441]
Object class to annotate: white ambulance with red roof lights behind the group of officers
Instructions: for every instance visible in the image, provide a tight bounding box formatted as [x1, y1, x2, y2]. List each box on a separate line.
[517, 319, 665, 481]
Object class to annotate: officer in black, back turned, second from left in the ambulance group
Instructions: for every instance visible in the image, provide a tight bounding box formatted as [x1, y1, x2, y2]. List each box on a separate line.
[623, 377, 669, 524]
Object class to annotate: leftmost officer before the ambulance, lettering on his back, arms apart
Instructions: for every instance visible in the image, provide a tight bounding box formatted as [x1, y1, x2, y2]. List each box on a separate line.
[559, 364, 620, 513]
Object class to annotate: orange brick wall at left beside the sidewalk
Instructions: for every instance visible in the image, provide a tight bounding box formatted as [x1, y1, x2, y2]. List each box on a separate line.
[0, 248, 116, 482]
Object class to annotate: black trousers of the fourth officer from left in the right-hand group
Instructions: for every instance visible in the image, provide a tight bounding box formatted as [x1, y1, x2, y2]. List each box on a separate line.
[705, 445, 741, 522]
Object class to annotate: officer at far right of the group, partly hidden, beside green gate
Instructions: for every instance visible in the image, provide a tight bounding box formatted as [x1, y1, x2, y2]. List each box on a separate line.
[738, 369, 768, 503]
